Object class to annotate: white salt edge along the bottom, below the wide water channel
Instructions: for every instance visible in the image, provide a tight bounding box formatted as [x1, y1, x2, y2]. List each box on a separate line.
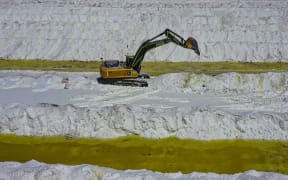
[0, 160, 288, 180]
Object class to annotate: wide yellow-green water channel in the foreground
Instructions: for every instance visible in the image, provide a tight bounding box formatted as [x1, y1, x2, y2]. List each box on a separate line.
[0, 135, 288, 174]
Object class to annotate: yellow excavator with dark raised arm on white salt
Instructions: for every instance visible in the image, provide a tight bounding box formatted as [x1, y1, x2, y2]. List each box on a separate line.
[97, 29, 200, 87]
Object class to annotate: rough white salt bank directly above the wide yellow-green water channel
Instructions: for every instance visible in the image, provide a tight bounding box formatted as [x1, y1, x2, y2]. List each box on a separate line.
[0, 104, 288, 140]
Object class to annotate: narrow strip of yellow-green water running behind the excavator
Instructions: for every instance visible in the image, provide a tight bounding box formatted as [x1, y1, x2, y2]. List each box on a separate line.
[0, 59, 288, 76]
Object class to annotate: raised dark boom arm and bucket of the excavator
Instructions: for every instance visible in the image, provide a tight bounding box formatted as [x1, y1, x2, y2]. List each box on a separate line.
[126, 29, 200, 73]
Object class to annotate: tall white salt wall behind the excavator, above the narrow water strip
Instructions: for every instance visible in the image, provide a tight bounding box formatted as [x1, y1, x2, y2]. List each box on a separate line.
[0, 0, 288, 62]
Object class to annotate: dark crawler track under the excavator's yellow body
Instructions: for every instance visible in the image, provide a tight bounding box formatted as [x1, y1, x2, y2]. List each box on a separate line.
[97, 77, 148, 87]
